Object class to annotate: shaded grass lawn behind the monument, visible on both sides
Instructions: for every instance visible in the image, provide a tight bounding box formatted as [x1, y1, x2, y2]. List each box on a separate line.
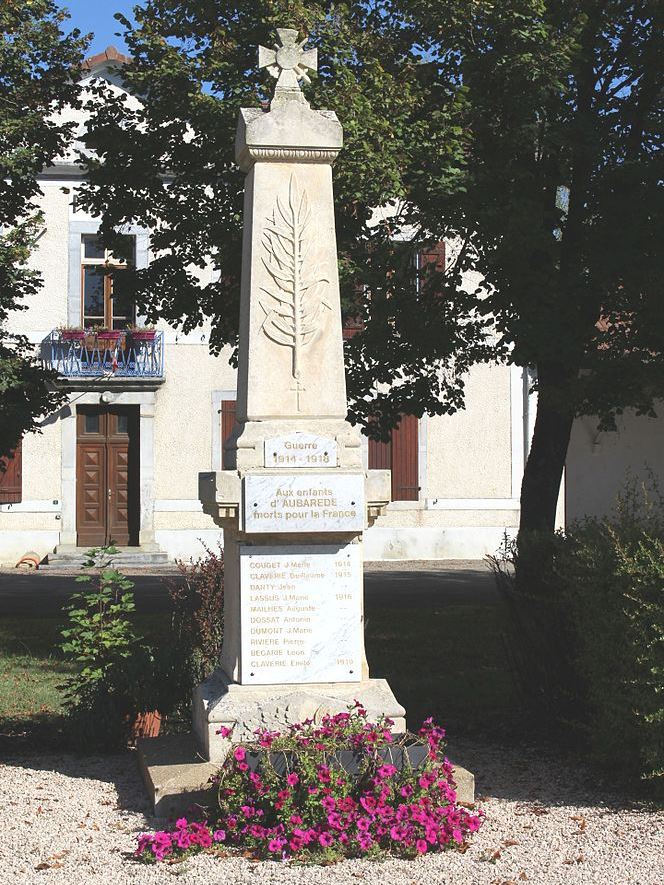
[0, 572, 517, 749]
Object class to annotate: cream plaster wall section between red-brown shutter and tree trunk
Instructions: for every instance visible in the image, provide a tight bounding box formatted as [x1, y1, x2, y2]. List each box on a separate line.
[427, 365, 522, 498]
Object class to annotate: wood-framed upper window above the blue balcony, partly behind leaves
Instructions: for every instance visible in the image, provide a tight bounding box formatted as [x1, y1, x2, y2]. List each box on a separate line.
[81, 234, 136, 329]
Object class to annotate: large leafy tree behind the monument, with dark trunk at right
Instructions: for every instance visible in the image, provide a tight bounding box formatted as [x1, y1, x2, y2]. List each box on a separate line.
[80, 0, 664, 531]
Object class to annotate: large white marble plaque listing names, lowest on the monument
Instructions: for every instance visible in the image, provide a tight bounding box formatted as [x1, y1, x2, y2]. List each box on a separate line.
[240, 544, 362, 685]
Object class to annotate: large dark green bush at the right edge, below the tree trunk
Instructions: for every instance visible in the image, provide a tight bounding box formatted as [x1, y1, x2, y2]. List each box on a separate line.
[494, 483, 664, 789]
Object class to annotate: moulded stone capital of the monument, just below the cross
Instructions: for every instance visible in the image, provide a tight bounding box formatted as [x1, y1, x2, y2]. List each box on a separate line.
[235, 101, 343, 172]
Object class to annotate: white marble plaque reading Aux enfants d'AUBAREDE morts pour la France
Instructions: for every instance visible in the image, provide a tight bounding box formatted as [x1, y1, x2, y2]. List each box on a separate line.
[243, 473, 365, 534]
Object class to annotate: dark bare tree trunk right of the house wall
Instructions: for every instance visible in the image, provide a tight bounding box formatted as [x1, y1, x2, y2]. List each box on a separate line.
[519, 363, 576, 534]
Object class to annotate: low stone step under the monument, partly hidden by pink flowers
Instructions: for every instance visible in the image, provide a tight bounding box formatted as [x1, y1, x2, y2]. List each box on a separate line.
[137, 734, 475, 818]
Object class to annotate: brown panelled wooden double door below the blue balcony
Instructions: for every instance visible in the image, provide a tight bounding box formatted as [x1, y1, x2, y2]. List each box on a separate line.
[76, 406, 140, 547]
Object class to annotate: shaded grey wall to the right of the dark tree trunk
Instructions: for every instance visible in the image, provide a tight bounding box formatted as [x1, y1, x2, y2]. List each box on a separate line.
[565, 410, 664, 524]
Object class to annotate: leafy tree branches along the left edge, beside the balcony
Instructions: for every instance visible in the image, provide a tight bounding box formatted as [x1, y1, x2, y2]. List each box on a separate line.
[0, 0, 87, 456]
